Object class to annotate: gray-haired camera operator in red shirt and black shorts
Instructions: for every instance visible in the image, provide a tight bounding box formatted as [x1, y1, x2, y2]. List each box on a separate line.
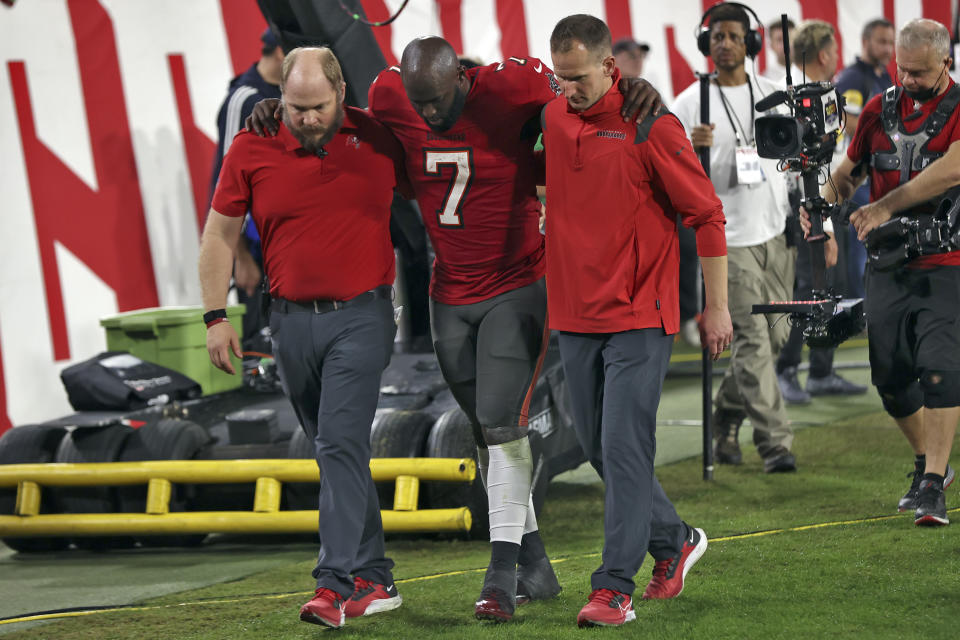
[804, 19, 960, 525]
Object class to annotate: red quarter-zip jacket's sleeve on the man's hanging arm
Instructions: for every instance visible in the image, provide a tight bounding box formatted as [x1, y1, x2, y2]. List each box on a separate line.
[637, 113, 727, 257]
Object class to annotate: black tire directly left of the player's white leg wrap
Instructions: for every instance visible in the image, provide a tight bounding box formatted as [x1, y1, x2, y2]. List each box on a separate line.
[424, 408, 490, 539]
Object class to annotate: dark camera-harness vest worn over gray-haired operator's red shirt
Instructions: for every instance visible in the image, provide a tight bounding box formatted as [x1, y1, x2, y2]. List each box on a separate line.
[870, 84, 960, 184]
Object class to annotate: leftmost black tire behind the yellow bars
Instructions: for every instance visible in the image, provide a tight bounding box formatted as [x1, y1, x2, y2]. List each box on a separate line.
[0, 424, 70, 553]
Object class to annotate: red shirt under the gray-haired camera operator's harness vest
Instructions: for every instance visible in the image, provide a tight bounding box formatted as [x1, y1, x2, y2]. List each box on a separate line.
[847, 82, 960, 268]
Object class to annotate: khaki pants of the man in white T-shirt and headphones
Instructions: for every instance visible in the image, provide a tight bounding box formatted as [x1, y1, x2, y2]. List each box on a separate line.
[716, 234, 796, 457]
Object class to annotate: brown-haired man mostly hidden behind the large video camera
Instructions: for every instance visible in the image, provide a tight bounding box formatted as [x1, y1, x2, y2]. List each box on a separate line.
[777, 20, 867, 404]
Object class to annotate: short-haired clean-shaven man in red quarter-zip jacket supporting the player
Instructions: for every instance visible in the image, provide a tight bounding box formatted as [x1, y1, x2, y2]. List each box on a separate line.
[543, 15, 733, 626]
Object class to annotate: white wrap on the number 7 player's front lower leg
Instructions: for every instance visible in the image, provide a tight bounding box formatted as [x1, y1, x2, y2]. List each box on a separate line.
[487, 438, 533, 544]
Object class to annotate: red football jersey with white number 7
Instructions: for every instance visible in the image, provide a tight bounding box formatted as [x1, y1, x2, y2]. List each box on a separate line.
[368, 58, 559, 304]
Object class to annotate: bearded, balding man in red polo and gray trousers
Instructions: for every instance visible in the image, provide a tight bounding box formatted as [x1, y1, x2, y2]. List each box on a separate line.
[200, 48, 403, 627]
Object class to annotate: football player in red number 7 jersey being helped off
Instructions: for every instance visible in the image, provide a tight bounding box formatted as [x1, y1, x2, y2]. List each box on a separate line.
[248, 37, 660, 621]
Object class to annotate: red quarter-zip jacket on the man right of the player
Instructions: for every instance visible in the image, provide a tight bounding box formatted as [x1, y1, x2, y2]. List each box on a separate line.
[542, 71, 727, 334]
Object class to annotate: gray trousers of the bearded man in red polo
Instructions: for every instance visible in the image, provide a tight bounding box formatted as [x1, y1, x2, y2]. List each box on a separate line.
[270, 299, 397, 598]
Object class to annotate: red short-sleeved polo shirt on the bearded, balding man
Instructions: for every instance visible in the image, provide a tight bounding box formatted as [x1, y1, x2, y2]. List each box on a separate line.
[212, 107, 403, 300]
